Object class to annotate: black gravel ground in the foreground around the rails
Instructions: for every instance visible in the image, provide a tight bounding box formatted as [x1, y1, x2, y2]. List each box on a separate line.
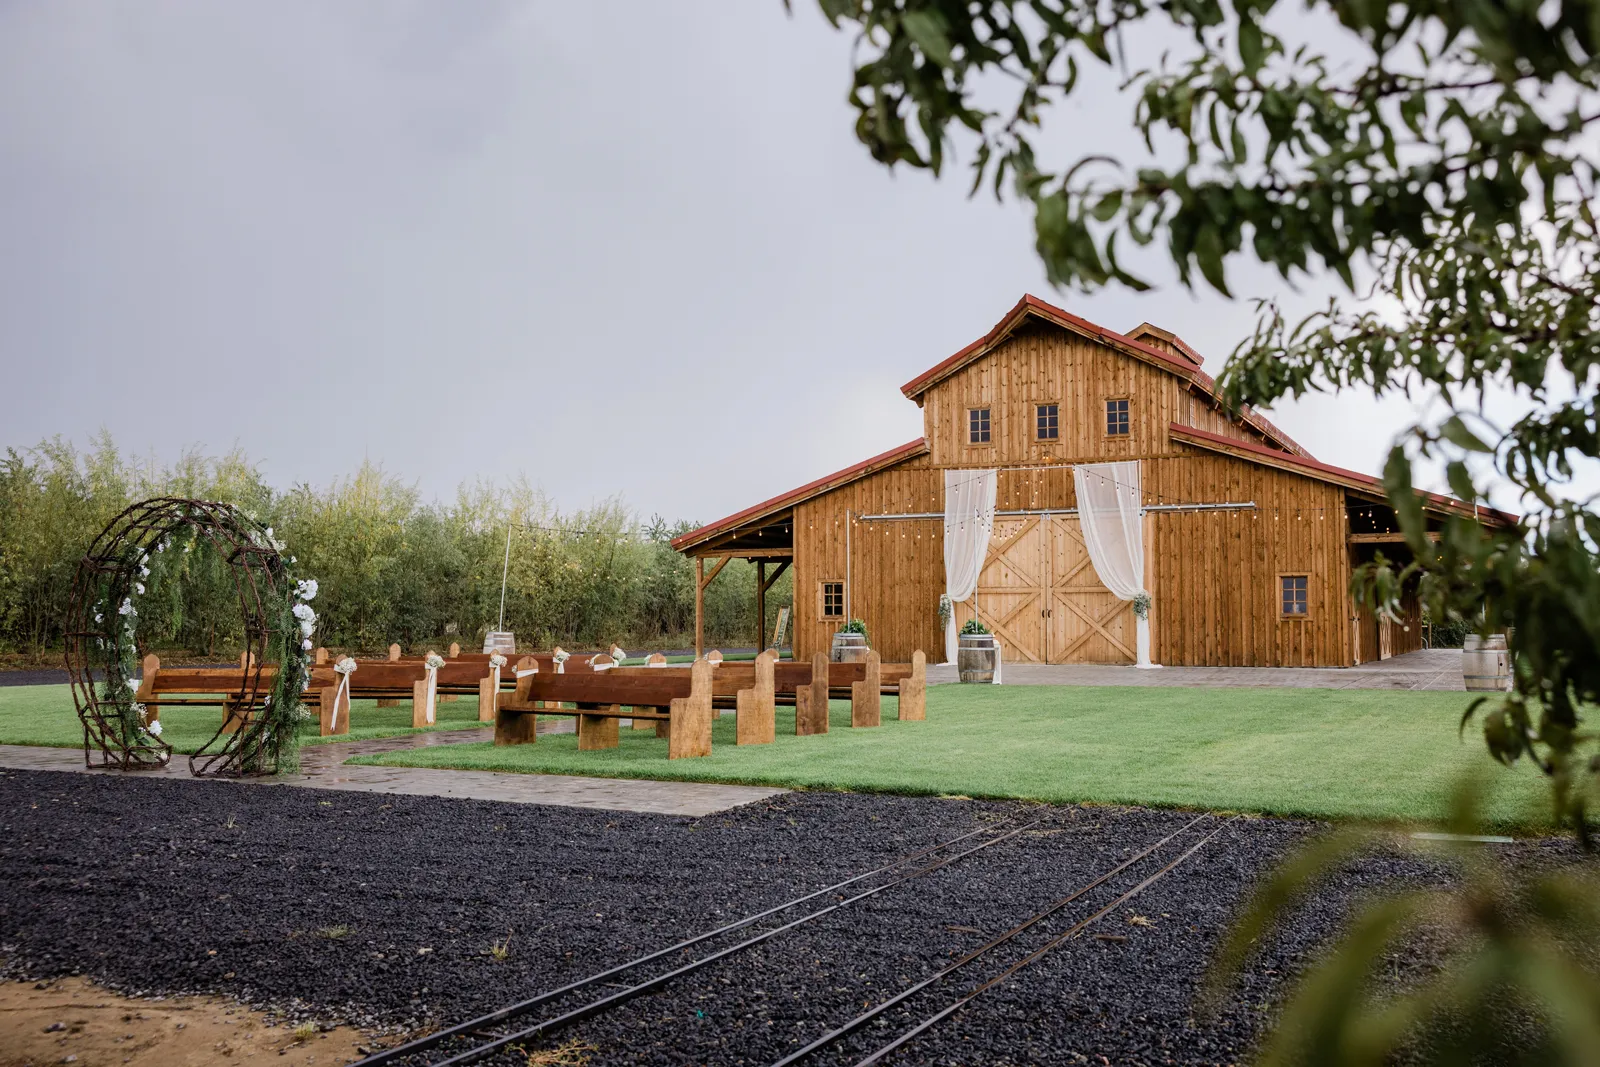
[0, 773, 1565, 1065]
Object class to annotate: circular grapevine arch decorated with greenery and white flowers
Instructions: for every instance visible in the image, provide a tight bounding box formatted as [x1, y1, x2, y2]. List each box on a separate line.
[66, 498, 310, 777]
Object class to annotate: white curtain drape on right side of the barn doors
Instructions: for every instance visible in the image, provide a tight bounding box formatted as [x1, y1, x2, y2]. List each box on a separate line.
[1072, 461, 1155, 667]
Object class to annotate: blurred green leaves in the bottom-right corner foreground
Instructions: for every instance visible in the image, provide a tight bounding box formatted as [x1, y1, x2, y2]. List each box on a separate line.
[1208, 781, 1600, 1067]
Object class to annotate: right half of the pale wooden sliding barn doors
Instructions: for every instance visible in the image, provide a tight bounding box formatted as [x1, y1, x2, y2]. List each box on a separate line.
[1040, 515, 1134, 664]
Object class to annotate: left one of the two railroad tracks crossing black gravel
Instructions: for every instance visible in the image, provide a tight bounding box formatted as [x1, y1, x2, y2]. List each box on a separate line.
[352, 819, 1040, 1067]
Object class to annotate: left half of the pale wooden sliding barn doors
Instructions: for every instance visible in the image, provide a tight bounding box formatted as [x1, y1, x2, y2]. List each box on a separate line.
[955, 515, 1050, 662]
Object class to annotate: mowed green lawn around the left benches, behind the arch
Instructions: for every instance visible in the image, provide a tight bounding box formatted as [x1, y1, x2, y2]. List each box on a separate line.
[0, 685, 478, 752]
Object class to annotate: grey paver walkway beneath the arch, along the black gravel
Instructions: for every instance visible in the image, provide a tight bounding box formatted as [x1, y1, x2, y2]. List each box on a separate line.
[0, 729, 789, 816]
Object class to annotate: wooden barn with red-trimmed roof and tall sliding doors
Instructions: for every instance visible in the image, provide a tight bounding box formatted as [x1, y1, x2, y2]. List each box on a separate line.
[674, 296, 1509, 667]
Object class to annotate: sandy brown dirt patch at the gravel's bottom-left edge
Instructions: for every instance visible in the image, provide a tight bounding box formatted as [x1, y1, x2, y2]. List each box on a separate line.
[0, 977, 370, 1067]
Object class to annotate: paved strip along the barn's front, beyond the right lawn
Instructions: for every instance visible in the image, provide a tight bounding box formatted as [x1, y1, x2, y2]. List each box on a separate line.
[928, 648, 1462, 689]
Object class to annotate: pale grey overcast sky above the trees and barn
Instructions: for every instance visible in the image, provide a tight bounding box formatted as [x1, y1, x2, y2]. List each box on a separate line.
[0, 0, 1548, 520]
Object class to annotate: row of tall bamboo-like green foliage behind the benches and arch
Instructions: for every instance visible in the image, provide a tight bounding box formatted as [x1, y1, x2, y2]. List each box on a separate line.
[0, 435, 790, 657]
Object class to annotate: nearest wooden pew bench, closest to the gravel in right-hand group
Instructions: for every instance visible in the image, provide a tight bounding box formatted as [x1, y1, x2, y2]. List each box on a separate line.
[494, 659, 715, 760]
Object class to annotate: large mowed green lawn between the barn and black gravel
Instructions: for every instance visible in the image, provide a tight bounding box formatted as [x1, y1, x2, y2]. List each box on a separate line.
[352, 685, 1547, 829]
